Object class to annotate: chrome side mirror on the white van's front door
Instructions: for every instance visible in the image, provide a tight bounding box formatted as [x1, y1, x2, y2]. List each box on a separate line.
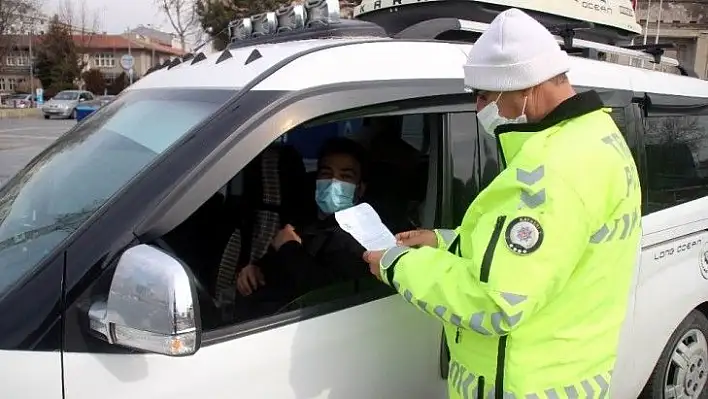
[88, 245, 201, 356]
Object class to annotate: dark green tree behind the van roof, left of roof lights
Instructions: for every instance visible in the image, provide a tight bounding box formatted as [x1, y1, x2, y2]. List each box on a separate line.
[195, 0, 292, 50]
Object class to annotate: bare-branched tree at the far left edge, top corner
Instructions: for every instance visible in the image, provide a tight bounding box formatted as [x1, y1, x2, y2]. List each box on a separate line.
[0, 0, 40, 64]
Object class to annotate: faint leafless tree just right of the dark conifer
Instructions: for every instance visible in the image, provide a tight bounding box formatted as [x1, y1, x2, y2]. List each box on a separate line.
[59, 0, 100, 71]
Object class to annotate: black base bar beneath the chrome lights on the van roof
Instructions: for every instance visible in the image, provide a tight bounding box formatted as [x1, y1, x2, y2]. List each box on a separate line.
[228, 19, 389, 49]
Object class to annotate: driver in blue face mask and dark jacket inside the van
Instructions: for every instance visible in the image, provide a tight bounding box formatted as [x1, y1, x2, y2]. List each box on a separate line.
[236, 138, 369, 318]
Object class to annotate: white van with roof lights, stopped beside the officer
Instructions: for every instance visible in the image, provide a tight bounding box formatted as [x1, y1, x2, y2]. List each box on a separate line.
[0, 1, 708, 399]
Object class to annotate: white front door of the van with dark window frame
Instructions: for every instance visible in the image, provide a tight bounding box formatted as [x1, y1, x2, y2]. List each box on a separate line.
[64, 81, 470, 399]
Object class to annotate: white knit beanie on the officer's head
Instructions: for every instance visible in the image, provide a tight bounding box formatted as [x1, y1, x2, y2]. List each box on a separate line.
[464, 8, 570, 92]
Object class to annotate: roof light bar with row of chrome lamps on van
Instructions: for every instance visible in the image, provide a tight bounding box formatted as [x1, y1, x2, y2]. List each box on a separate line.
[228, 0, 389, 49]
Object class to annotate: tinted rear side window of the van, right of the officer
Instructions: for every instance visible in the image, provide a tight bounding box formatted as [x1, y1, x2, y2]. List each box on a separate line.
[645, 112, 708, 212]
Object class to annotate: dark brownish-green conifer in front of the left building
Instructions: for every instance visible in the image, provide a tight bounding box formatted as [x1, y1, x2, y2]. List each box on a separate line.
[35, 15, 81, 97]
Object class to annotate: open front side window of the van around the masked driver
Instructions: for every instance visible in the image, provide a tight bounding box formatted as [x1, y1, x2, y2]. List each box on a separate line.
[158, 114, 442, 329]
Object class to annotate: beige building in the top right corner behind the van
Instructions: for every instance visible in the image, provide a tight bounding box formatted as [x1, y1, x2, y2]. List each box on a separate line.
[635, 0, 708, 79]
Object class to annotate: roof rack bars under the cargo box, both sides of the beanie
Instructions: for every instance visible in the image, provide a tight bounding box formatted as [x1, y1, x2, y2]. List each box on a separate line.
[394, 18, 697, 77]
